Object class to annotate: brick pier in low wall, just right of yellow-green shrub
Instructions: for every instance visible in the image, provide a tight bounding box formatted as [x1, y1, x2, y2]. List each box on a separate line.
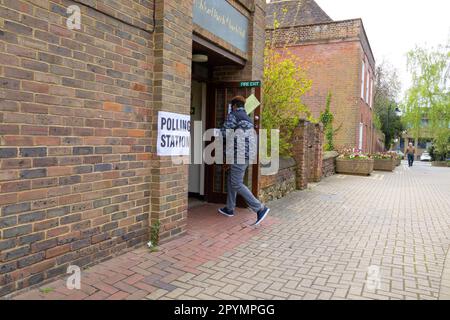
[292, 120, 309, 190]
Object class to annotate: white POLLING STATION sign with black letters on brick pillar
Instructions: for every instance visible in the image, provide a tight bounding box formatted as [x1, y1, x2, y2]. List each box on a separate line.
[157, 111, 191, 156]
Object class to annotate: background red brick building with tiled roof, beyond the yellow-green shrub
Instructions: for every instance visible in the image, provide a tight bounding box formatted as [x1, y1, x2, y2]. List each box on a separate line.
[266, 0, 381, 152]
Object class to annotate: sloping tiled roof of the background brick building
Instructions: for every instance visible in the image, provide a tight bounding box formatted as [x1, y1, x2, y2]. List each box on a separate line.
[266, 0, 333, 29]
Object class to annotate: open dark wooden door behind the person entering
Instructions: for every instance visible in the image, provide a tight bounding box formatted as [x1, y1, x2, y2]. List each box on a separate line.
[205, 82, 261, 206]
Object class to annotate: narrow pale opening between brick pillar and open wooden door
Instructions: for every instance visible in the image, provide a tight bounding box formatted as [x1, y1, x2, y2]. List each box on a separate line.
[188, 79, 207, 208]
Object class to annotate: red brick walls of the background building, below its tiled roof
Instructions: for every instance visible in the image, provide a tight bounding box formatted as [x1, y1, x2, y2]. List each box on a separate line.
[268, 19, 375, 152]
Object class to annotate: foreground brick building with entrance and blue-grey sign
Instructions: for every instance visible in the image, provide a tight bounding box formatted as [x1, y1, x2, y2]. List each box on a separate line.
[0, 0, 265, 296]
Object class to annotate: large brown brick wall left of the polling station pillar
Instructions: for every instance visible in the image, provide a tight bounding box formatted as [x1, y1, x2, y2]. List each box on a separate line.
[0, 0, 153, 296]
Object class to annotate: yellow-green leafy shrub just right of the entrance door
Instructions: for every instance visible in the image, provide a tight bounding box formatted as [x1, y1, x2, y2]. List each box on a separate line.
[262, 45, 311, 156]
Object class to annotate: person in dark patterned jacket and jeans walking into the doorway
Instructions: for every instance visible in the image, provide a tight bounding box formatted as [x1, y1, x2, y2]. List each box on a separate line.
[219, 96, 270, 226]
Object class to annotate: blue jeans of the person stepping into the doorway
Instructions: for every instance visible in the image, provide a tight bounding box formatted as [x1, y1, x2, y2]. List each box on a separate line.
[227, 164, 263, 212]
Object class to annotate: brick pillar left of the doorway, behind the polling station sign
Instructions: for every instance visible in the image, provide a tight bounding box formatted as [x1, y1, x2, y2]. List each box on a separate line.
[150, 0, 193, 242]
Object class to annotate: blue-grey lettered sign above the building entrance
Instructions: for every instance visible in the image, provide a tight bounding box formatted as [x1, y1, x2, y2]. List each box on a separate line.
[193, 0, 249, 53]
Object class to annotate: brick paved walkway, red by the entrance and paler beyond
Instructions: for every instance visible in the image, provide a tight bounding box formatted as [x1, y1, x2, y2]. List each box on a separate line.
[8, 163, 450, 299]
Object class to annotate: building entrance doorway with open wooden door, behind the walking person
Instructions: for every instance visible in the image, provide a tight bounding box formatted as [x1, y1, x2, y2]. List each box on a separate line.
[188, 34, 261, 208]
